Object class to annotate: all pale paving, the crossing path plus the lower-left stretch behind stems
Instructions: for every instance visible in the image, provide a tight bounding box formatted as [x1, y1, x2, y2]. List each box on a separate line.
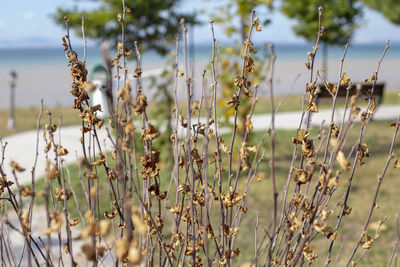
[3, 105, 400, 266]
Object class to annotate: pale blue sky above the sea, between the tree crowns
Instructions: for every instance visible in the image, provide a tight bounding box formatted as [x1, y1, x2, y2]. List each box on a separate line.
[0, 0, 400, 47]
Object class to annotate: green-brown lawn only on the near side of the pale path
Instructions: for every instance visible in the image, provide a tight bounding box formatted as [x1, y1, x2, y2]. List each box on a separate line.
[32, 118, 400, 266]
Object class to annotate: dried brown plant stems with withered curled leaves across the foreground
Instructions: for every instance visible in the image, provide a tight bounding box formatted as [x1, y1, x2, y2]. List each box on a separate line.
[0, 1, 400, 266]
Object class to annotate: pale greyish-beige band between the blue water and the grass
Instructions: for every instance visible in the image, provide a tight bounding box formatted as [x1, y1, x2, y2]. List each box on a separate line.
[0, 55, 400, 109]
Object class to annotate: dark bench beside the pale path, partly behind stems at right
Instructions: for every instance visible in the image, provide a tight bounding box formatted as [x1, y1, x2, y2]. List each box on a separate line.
[315, 83, 385, 106]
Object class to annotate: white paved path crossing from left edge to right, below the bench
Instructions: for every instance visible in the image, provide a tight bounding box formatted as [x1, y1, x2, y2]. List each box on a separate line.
[3, 105, 400, 184]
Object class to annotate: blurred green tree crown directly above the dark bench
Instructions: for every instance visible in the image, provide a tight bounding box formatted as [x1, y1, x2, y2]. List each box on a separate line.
[281, 0, 362, 45]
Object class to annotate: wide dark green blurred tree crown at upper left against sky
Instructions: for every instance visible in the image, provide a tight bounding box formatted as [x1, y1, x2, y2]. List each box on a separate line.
[54, 0, 195, 54]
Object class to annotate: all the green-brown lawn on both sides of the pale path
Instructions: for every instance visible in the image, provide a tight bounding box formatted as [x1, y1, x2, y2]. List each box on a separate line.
[8, 86, 400, 266]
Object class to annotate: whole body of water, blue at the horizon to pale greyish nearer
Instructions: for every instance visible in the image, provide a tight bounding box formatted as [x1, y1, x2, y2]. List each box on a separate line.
[0, 43, 400, 109]
